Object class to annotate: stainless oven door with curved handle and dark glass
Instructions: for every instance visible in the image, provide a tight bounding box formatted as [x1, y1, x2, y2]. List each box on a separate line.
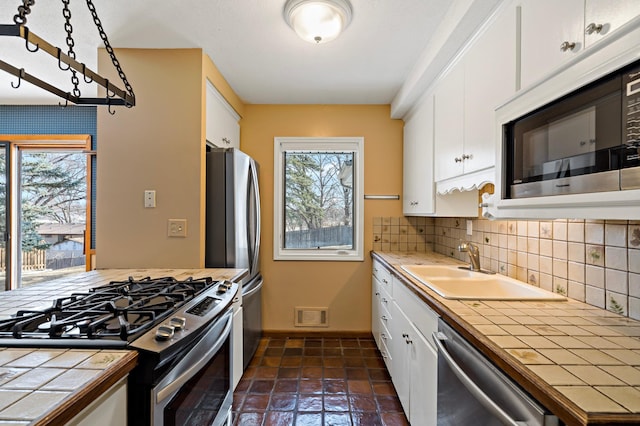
[151, 308, 233, 426]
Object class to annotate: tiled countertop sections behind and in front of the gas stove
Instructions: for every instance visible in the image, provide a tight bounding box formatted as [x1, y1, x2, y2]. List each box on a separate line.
[0, 269, 246, 425]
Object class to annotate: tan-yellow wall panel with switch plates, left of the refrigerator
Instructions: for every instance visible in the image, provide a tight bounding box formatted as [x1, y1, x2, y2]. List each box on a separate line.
[96, 49, 210, 268]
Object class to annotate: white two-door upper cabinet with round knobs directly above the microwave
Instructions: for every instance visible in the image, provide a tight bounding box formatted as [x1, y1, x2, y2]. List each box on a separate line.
[521, 0, 640, 88]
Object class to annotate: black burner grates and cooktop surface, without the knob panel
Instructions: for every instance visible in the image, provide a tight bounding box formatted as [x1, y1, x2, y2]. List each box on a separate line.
[0, 277, 217, 342]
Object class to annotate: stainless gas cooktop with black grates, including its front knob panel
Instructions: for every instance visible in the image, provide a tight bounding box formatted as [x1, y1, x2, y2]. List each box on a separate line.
[0, 277, 237, 351]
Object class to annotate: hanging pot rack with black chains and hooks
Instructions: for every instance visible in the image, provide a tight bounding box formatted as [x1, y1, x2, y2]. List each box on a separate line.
[0, 0, 136, 114]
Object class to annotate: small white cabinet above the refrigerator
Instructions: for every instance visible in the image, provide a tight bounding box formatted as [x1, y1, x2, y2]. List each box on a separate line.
[206, 80, 240, 148]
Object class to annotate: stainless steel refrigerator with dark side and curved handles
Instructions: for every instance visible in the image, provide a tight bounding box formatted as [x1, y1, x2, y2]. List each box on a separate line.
[205, 148, 262, 369]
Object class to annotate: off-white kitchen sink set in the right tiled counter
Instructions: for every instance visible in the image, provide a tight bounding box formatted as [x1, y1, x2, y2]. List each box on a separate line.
[402, 265, 566, 301]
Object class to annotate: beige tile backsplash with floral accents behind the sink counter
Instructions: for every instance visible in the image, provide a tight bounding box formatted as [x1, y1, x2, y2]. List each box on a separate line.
[373, 217, 640, 319]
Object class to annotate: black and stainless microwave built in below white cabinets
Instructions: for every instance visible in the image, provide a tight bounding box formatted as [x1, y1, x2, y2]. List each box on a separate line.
[502, 61, 640, 198]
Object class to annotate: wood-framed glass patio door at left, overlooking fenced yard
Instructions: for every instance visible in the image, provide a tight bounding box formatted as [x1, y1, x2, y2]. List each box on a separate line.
[0, 135, 95, 290]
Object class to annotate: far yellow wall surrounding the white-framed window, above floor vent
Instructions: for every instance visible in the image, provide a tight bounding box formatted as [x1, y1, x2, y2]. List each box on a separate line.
[241, 105, 402, 332]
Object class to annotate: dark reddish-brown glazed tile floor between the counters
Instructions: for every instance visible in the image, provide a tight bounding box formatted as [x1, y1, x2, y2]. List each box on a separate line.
[232, 337, 409, 426]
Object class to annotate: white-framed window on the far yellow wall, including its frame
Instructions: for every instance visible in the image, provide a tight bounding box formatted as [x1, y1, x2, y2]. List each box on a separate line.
[273, 137, 364, 261]
